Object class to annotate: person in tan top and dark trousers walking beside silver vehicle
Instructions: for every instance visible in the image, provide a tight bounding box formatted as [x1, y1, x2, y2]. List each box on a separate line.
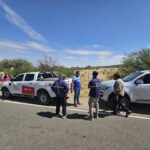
[113, 73, 131, 117]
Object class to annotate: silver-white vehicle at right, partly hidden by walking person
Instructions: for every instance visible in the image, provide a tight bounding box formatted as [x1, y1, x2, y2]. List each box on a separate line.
[100, 70, 150, 105]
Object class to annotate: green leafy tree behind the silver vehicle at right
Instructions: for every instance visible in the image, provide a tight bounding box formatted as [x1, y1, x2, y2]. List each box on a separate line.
[119, 48, 150, 75]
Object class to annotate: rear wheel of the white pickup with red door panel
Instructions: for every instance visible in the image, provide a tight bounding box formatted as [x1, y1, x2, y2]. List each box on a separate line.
[37, 91, 50, 105]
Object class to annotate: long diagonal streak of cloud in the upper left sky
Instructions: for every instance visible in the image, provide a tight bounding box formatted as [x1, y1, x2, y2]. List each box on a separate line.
[0, 0, 46, 42]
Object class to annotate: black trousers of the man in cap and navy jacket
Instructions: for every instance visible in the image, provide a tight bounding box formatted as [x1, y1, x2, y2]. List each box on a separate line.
[56, 97, 67, 116]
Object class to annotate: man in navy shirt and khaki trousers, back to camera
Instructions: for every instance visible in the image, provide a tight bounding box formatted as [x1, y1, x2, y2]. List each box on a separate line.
[88, 71, 101, 121]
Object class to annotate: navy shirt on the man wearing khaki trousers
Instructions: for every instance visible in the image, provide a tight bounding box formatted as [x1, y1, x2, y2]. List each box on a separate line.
[88, 78, 101, 98]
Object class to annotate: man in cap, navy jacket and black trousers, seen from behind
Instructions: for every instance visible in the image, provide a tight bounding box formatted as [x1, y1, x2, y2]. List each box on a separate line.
[52, 74, 69, 119]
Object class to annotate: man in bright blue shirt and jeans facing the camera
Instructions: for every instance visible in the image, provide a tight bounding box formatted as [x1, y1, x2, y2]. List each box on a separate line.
[71, 71, 81, 107]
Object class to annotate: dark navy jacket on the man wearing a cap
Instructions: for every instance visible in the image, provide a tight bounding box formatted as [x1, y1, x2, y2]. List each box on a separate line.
[52, 79, 69, 97]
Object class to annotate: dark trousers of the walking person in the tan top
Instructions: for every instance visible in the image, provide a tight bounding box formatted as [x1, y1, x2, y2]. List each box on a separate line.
[113, 95, 129, 114]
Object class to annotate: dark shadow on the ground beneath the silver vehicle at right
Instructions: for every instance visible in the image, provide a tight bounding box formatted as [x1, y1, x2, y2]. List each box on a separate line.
[99, 101, 150, 115]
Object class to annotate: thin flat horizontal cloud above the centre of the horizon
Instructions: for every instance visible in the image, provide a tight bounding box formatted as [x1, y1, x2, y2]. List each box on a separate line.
[64, 49, 113, 56]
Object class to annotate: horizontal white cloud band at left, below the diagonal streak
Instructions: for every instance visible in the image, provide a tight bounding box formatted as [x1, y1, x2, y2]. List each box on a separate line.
[0, 41, 53, 53]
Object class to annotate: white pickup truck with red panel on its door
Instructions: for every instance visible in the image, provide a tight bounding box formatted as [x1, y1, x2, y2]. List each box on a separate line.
[1, 72, 72, 105]
